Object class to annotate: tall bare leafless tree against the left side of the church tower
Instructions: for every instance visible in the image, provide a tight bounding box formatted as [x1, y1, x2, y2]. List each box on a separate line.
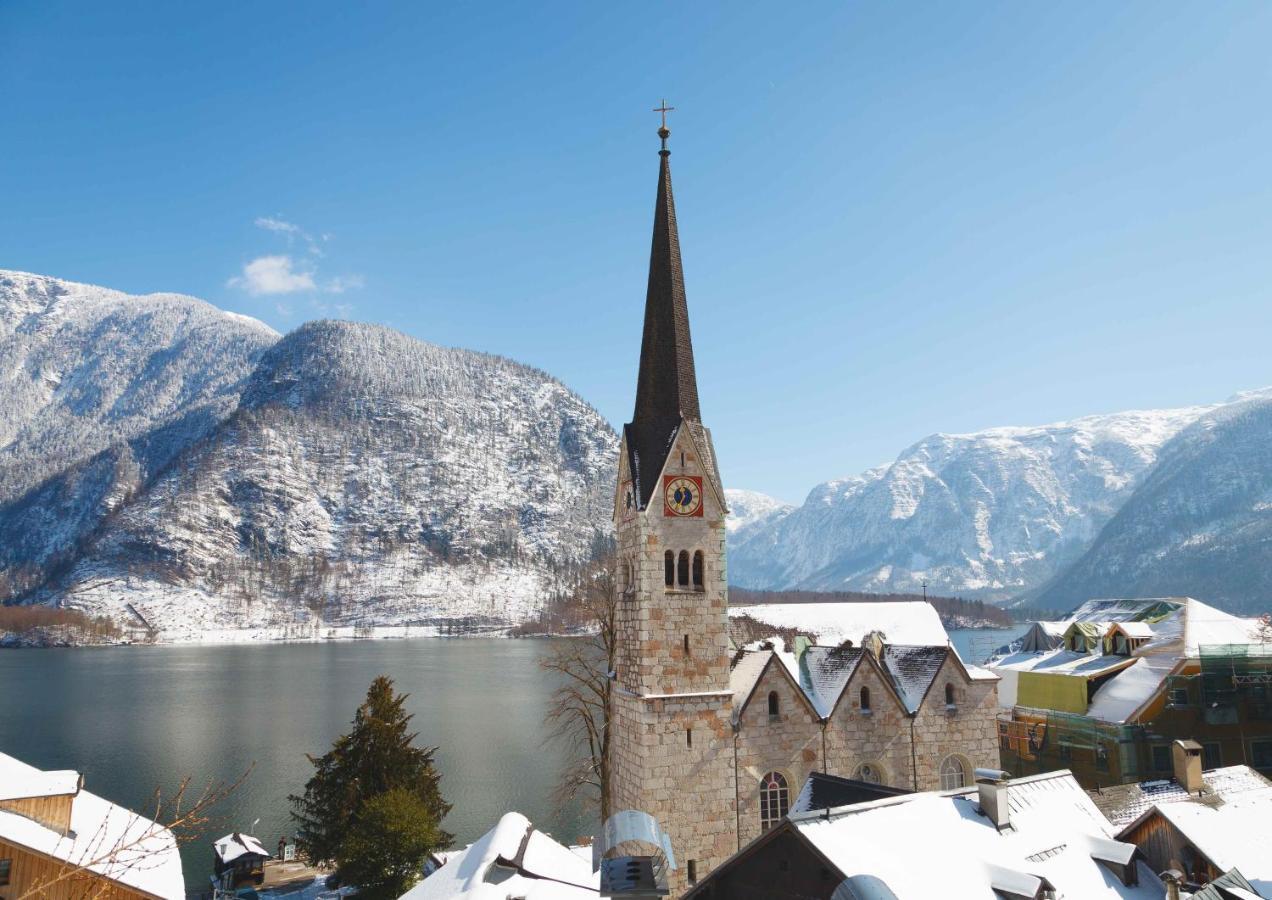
[539, 557, 618, 821]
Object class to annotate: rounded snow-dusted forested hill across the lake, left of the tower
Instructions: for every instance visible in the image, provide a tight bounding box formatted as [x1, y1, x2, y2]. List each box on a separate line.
[50, 322, 617, 639]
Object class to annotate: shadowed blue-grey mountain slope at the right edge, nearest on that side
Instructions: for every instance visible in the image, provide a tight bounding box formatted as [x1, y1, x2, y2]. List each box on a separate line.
[1028, 393, 1272, 613]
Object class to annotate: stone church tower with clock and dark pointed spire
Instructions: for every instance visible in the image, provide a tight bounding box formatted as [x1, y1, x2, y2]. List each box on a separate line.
[611, 104, 738, 896]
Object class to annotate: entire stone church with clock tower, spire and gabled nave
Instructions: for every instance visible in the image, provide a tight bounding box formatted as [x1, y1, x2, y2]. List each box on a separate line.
[609, 111, 999, 896]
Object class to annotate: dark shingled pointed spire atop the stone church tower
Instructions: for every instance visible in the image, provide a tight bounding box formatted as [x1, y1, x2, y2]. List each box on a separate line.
[626, 125, 702, 507]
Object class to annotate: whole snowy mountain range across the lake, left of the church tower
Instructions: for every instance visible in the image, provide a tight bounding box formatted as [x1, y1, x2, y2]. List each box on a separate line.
[0, 270, 617, 639]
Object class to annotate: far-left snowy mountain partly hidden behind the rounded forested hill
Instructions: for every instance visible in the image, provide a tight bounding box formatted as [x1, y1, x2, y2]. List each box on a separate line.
[0, 269, 279, 599]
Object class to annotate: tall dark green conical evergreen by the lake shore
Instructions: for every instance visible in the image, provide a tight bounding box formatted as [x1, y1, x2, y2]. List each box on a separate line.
[290, 675, 452, 883]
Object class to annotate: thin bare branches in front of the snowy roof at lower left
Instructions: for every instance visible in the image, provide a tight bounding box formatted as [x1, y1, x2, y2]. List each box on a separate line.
[15, 769, 251, 900]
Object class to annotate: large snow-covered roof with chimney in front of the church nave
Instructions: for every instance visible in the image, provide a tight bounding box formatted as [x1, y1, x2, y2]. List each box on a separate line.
[790, 772, 1164, 900]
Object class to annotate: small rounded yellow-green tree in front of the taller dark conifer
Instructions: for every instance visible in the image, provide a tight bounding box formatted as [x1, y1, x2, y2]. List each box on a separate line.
[336, 788, 446, 900]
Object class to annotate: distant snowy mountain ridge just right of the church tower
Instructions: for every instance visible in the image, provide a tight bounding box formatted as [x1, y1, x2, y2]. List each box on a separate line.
[729, 403, 1261, 599]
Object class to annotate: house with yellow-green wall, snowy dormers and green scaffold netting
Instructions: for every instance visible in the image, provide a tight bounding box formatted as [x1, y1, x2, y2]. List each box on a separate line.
[988, 597, 1272, 787]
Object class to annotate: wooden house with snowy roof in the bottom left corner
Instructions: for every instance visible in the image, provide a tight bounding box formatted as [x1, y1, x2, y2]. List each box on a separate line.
[0, 754, 186, 900]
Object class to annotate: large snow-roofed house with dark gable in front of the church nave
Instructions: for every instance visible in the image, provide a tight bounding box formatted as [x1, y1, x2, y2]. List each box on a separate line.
[686, 772, 1165, 900]
